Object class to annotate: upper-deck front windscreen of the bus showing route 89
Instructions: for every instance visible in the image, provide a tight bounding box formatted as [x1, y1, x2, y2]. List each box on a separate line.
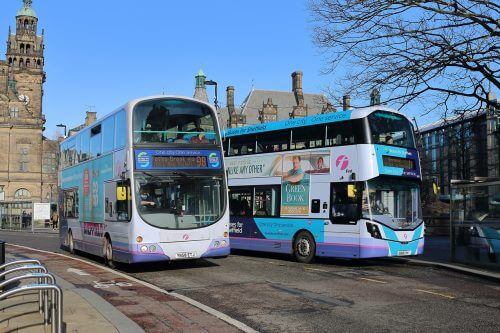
[133, 99, 219, 144]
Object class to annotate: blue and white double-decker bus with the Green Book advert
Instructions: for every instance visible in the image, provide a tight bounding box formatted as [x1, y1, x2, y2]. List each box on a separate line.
[223, 106, 424, 262]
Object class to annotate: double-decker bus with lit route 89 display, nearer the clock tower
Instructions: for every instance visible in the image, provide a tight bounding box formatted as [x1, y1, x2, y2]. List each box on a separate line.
[59, 96, 229, 265]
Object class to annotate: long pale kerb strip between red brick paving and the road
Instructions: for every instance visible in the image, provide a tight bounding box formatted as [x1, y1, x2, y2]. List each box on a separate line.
[9, 243, 258, 333]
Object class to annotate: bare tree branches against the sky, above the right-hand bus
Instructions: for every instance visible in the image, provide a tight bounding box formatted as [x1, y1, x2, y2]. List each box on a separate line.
[309, 0, 500, 116]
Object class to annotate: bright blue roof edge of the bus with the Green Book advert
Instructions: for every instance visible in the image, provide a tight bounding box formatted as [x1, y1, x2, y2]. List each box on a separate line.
[222, 105, 407, 137]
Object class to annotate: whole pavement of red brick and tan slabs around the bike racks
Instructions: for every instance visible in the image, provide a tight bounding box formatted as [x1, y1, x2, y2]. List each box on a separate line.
[0, 245, 248, 333]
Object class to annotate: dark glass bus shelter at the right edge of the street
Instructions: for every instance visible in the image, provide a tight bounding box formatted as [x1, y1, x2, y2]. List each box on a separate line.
[450, 177, 500, 269]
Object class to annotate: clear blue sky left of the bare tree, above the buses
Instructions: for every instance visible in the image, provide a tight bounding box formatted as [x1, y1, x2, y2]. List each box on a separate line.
[0, 0, 426, 137]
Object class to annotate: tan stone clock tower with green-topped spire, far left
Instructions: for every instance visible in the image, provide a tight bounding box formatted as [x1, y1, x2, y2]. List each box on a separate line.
[0, 0, 59, 208]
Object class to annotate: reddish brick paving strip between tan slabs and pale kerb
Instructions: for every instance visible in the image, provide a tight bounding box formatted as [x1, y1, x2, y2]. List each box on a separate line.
[6, 245, 240, 333]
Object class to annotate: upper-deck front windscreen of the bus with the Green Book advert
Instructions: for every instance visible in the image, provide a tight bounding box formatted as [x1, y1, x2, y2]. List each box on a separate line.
[368, 111, 415, 148]
